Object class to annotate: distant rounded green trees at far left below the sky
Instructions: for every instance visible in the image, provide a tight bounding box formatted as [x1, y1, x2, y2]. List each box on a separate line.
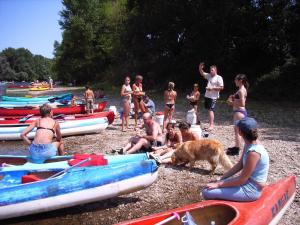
[0, 48, 55, 81]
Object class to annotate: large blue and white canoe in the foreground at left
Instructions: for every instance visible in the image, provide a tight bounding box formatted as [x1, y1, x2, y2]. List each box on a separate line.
[0, 160, 158, 219]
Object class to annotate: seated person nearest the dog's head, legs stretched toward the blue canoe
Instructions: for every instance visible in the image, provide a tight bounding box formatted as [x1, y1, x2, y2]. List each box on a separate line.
[150, 122, 199, 163]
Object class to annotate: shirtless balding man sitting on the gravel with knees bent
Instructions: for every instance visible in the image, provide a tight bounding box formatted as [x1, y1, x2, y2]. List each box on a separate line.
[121, 112, 163, 154]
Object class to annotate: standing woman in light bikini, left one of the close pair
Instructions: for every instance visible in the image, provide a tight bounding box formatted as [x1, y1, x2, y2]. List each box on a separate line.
[121, 77, 132, 132]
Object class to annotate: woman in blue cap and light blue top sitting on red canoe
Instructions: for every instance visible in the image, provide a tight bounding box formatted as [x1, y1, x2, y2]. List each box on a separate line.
[202, 117, 269, 202]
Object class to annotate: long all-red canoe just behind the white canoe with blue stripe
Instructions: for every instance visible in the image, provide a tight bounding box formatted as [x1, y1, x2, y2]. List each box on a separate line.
[0, 101, 107, 116]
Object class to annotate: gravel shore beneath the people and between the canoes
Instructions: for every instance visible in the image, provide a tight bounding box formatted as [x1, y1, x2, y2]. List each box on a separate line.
[3, 90, 300, 225]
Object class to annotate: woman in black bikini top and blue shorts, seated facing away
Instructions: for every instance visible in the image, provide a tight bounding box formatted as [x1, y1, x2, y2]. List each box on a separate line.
[21, 104, 64, 163]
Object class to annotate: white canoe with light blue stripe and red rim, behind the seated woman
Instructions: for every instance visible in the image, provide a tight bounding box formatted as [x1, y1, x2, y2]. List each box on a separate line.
[0, 112, 108, 140]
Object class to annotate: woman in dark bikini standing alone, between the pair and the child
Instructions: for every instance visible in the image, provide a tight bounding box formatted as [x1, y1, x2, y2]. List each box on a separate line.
[163, 82, 177, 132]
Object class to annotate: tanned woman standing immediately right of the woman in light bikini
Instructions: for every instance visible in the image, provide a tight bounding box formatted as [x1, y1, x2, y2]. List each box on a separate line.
[132, 75, 147, 130]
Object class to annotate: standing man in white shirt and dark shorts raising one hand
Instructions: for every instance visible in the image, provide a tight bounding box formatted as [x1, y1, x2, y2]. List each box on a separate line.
[199, 62, 224, 131]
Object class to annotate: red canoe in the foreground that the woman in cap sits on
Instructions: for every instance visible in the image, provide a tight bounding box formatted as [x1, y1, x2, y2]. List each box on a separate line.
[120, 176, 296, 225]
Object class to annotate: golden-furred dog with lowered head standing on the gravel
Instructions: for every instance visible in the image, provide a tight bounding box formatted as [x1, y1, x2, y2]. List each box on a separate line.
[171, 139, 232, 174]
